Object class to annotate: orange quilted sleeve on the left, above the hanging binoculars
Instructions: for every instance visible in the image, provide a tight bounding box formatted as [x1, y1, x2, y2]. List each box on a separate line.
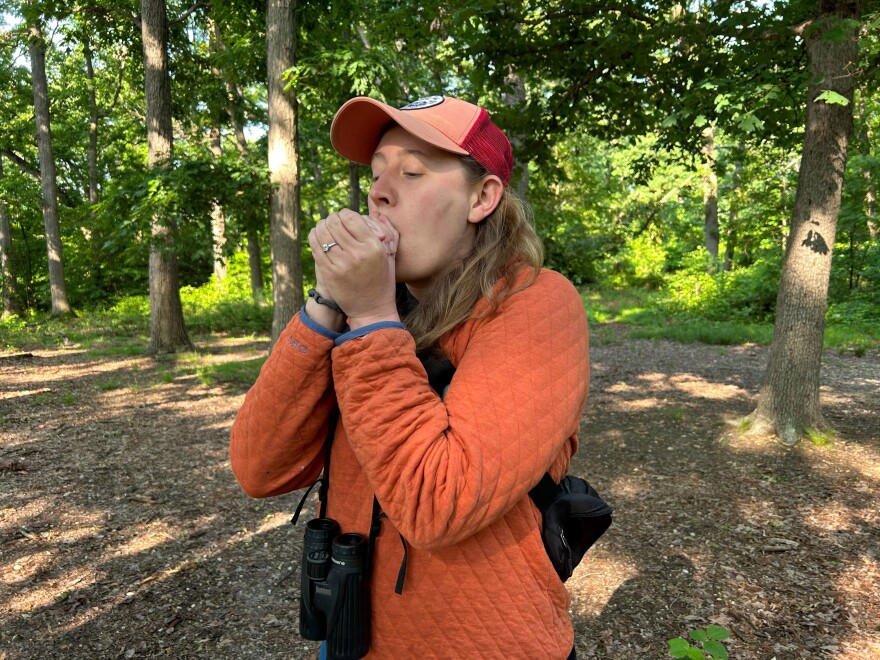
[229, 313, 335, 497]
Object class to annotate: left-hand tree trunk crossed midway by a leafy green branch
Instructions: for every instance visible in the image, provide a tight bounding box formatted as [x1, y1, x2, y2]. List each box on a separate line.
[141, 0, 193, 353]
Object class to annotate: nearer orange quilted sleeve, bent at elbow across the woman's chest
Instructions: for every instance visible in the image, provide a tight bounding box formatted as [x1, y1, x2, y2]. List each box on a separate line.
[333, 271, 589, 548]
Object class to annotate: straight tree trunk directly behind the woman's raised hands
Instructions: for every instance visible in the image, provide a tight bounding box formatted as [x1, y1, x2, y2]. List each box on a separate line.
[266, 0, 303, 346]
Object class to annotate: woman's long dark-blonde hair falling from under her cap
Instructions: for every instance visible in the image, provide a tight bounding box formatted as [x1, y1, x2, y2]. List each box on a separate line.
[403, 156, 544, 351]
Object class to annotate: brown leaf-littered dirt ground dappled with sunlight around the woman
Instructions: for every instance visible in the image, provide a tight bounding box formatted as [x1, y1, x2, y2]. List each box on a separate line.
[0, 337, 880, 660]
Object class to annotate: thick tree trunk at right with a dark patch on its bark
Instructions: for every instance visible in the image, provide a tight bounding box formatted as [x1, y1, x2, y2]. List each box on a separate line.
[750, 0, 859, 445]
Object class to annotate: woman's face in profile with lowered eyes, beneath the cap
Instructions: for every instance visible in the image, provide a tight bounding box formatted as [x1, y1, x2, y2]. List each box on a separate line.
[369, 126, 486, 298]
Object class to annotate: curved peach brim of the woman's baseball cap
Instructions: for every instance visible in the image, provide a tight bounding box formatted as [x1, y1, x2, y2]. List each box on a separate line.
[330, 96, 468, 165]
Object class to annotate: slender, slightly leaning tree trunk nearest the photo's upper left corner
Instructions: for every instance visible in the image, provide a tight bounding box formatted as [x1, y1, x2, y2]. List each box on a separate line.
[28, 15, 71, 316]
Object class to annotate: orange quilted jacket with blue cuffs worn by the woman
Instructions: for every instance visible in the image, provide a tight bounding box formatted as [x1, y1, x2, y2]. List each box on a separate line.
[230, 270, 589, 660]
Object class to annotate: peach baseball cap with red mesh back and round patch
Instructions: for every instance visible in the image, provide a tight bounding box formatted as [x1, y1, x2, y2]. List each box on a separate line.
[330, 96, 513, 185]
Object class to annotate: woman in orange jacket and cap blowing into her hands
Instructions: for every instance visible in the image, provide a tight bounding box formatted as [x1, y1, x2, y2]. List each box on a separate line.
[231, 96, 589, 660]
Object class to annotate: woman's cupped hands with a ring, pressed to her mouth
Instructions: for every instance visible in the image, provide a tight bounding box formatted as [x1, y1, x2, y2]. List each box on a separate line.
[309, 209, 399, 330]
